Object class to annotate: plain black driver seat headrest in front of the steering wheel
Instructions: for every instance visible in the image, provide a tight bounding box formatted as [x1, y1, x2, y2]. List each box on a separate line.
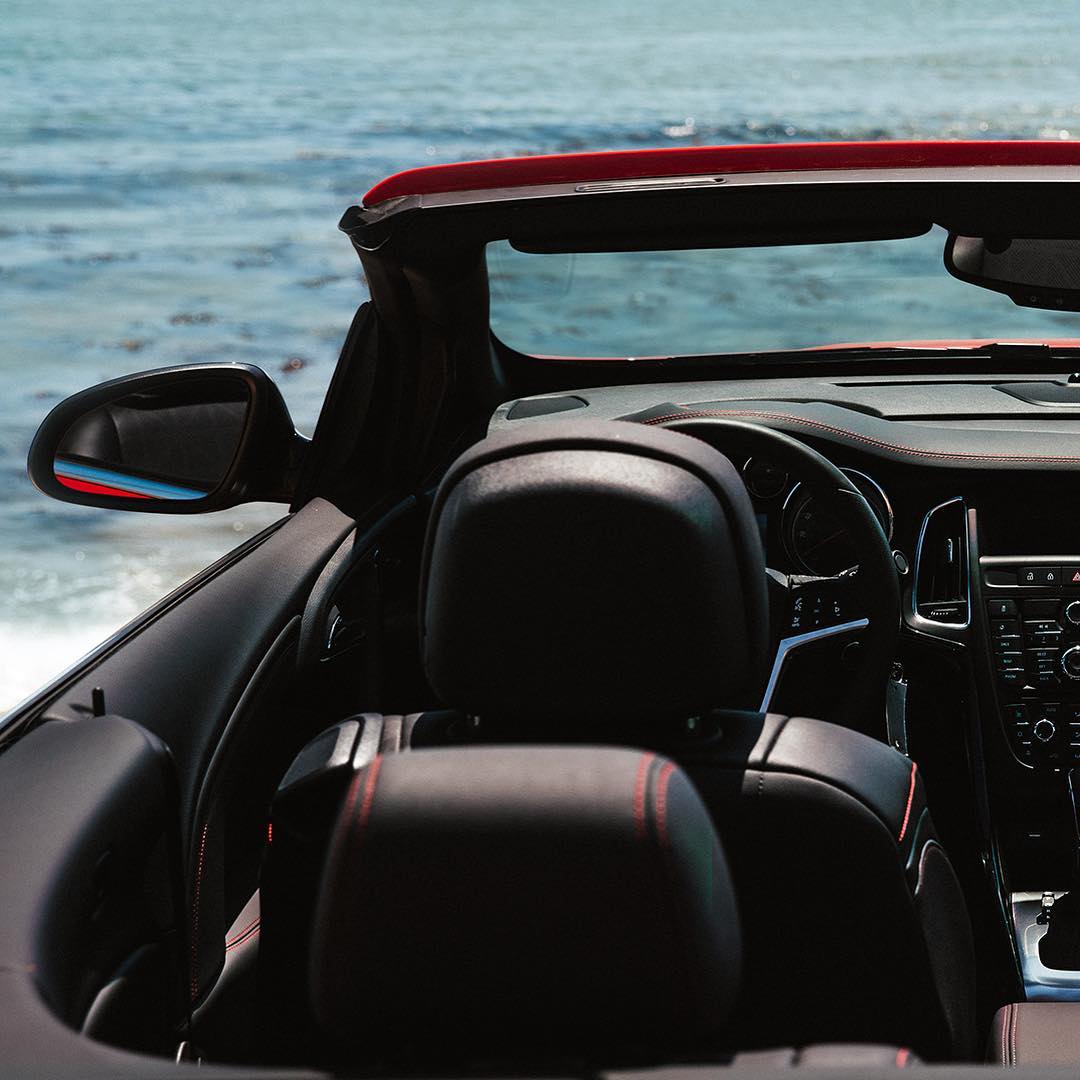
[420, 420, 767, 719]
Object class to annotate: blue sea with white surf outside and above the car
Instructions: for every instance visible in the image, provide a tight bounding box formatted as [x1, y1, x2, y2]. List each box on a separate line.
[0, 0, 1080, 710]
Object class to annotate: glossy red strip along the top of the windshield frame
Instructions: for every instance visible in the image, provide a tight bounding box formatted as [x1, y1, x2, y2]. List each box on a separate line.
[364, 139, 1080, 206]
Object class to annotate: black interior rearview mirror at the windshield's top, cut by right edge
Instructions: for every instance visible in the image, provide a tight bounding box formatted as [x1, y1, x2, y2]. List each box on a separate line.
[945, 233, 1080, 311]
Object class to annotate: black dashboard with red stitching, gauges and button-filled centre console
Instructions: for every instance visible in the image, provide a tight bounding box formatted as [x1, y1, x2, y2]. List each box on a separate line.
[490, 373, 1080, 902]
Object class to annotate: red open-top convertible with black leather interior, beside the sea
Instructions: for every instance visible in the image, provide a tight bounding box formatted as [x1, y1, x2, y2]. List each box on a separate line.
[14, 141, 1080, 1080]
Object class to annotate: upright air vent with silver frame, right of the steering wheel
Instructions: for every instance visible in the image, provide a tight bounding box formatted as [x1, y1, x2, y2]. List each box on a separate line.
[912, 497, 971, 626]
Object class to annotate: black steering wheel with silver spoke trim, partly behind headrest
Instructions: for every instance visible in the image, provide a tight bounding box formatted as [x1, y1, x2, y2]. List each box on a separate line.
[653, 418, 901, 739]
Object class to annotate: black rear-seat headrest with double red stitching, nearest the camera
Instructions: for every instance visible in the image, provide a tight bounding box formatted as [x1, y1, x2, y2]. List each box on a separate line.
[310, 746, 740, 1066]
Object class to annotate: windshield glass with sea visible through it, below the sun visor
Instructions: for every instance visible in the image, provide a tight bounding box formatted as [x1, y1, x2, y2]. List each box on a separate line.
[487, 227, 1080, 356]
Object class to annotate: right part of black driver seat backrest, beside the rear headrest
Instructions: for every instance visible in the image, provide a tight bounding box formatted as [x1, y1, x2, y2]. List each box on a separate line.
[675, 712, 975, 1059]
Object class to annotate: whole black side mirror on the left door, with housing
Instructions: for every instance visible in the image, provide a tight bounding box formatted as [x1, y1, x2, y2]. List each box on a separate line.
[27, 364, 308, 514]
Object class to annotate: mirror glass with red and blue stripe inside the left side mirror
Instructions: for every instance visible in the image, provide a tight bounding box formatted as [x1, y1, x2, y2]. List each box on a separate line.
[53, 379, 251, 499]
